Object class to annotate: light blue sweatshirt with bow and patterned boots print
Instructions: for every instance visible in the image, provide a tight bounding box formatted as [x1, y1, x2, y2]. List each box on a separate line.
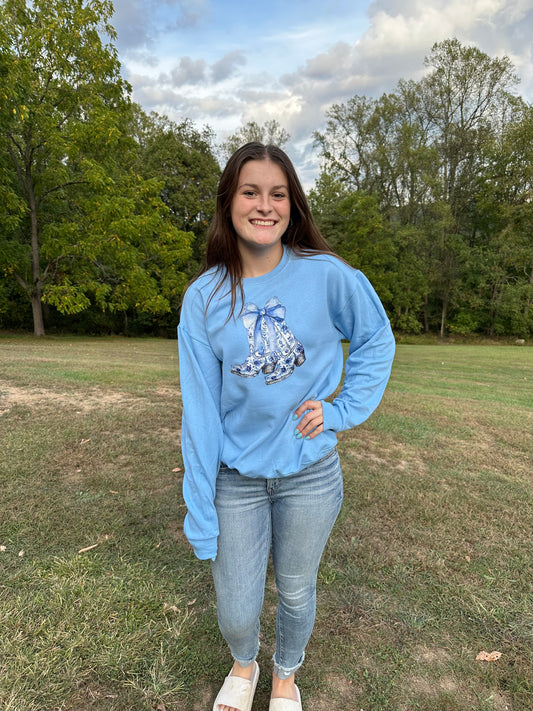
[178, 248, 395, 559]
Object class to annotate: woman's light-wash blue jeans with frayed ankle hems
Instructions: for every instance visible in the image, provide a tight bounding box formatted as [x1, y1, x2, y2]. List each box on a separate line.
[211, 449, 343, 679]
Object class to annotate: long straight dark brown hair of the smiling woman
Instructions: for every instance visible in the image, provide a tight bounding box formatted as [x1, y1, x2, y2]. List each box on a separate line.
[200, 141, 334, 316]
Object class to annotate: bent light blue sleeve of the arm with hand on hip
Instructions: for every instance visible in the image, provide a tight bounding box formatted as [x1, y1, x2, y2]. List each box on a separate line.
[323, 271, 395, 432]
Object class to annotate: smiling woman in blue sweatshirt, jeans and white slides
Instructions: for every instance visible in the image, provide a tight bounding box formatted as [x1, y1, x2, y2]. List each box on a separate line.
[178, 142, 394, 711]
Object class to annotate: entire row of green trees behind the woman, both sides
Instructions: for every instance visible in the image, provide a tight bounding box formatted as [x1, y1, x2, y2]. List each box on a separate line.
[0, 0, 533, 337]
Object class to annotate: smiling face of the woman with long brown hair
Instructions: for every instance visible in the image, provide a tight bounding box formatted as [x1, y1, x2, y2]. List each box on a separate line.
[231, 159, 291, 258]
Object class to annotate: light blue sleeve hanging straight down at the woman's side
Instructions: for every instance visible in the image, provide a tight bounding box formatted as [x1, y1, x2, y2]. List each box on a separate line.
[178, 292, 222, 560]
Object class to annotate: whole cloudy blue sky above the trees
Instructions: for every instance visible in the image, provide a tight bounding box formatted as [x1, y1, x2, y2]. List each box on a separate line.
[111, 0, 533, 188]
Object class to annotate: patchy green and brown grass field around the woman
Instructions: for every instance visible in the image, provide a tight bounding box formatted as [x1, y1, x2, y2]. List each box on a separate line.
[0, 337, 533, 711]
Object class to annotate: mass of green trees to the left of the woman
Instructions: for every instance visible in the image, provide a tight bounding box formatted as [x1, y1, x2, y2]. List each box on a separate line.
[0, 0, 219, 335]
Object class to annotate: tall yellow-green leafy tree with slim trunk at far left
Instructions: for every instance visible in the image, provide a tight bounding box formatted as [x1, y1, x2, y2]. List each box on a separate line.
[0, 0, 190, 335]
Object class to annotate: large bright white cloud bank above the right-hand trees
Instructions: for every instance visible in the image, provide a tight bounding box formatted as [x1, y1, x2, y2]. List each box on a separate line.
[276, 0, 533, 145]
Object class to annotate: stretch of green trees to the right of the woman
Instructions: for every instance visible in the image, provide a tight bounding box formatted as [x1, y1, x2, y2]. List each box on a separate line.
[311, 39, 533, 337]
